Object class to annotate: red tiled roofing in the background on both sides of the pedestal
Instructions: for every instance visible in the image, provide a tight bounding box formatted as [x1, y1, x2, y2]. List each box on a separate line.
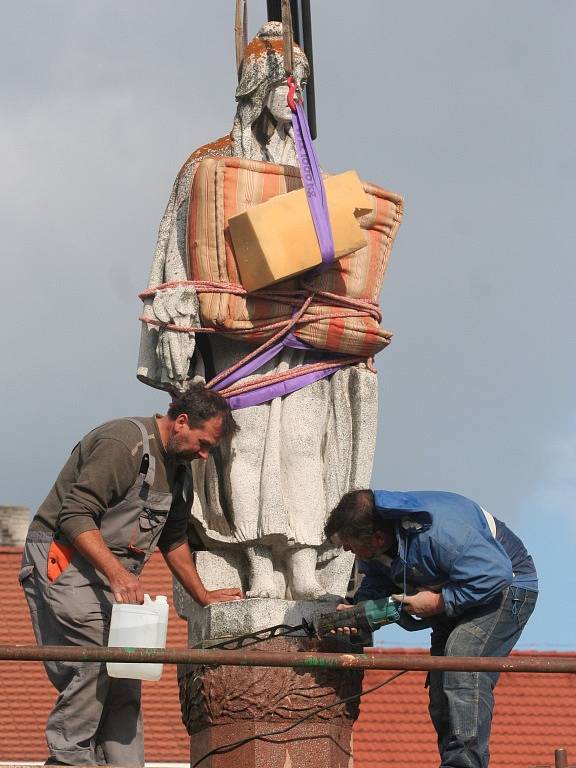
[0, 547, 576, 768]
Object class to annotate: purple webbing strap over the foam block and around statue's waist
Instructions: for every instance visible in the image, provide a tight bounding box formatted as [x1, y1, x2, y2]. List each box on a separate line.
[214, 101, 342, 410]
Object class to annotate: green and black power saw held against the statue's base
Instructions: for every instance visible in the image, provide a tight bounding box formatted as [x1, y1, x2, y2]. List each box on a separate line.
[200, 597, 431, 650]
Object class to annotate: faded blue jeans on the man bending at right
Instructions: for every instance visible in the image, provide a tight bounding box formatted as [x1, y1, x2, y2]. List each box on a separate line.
[428, 587, 537, 768]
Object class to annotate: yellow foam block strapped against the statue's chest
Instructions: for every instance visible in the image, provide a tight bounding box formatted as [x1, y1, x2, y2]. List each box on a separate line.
[228, 171, 372, 291]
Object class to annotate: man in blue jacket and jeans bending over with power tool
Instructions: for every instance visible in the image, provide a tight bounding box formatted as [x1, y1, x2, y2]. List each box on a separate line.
[325, 490, 538, 768]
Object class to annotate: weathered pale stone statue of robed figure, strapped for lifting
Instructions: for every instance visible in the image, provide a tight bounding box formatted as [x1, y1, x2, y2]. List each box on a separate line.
[138, 22, 378, 600]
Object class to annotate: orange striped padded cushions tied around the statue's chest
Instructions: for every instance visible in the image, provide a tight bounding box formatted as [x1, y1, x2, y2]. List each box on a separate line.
[142, 157, 403, 358]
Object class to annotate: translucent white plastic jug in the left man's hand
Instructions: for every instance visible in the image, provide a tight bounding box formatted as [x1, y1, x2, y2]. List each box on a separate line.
[106, 595, 168, 680]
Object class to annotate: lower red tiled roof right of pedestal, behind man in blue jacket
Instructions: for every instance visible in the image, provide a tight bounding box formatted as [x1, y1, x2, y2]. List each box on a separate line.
[354, 648, 576, 768]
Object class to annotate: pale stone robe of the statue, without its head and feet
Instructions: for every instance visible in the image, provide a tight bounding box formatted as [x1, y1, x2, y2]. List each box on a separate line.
[137, 134, 378, 560]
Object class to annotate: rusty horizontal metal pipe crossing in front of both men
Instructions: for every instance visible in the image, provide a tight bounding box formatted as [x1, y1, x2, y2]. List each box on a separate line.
[0, 645, 576, 672]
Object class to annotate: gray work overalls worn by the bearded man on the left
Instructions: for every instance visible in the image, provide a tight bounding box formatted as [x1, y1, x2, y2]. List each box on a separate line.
[20, 419, 180, 768]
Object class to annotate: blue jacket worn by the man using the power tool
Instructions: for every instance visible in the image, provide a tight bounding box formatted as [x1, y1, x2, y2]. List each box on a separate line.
[354, 491, 537, 616]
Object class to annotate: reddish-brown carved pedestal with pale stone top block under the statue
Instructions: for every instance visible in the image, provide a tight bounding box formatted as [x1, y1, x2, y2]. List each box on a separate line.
[178, 599, 362, 768]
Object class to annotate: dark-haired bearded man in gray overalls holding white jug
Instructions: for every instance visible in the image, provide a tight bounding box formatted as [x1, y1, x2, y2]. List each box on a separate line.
[20, 385, 242, 767]
